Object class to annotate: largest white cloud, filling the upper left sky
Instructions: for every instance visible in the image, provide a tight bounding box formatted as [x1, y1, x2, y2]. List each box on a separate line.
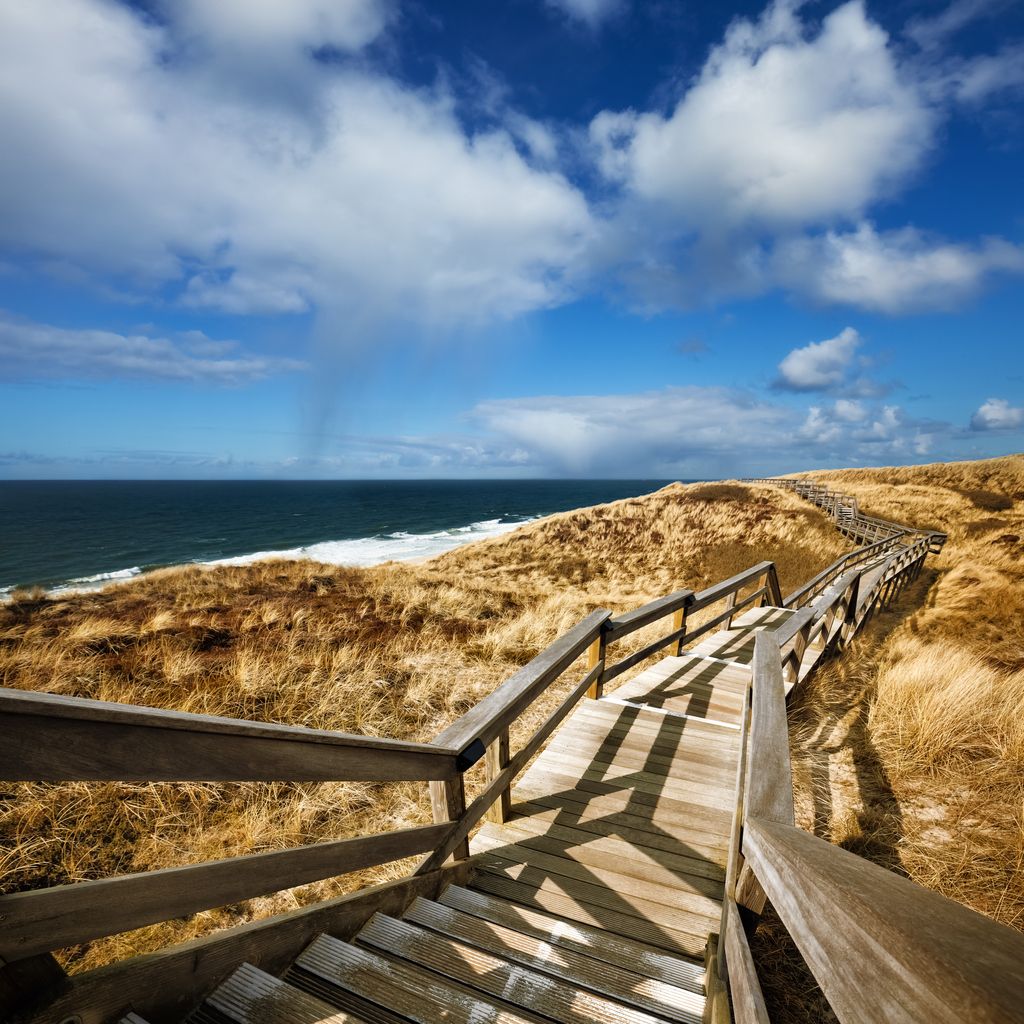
[0, 0, 592, 329]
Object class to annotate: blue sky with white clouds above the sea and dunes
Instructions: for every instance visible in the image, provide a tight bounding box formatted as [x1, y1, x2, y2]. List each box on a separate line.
[0, 0, 1024, 479]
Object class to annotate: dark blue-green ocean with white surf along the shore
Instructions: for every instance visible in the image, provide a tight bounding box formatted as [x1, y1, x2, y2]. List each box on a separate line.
[0, 480, 670, 597]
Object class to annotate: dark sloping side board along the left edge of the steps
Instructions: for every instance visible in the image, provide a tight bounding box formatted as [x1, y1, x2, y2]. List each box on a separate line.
[28, 861, 472, 1024]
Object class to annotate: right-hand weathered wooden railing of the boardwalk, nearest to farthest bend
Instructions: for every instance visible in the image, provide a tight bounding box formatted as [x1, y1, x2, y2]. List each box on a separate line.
[708, 481, 1024, 1024]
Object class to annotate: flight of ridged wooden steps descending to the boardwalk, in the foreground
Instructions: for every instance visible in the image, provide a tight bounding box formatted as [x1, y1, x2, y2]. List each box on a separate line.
[190, 885, 705, 1024]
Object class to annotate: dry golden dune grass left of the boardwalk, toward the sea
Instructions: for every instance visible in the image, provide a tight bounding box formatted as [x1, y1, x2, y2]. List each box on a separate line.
[0, 484, 845, 970]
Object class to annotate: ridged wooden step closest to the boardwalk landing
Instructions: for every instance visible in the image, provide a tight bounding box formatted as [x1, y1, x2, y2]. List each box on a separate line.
[438, 886, 703, 992]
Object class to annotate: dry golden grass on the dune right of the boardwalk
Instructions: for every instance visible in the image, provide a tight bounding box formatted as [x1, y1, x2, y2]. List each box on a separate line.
[756, 456, 1024, 1022]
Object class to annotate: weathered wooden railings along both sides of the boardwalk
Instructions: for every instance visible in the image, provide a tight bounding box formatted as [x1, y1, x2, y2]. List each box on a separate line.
[0, 480, 1024, 1024]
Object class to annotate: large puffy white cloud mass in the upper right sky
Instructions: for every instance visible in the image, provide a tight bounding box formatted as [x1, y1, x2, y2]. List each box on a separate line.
[589, 0, 1024, 312]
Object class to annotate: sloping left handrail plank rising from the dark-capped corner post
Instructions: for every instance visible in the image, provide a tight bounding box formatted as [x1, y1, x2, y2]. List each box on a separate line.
[434, 609, 611, 751]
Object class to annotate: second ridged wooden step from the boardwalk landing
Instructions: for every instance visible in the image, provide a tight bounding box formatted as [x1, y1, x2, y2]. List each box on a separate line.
[404, 898, 703, 1024]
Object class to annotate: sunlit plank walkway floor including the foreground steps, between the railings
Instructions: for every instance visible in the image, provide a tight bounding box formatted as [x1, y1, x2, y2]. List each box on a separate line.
[194, 607, 795, 1024]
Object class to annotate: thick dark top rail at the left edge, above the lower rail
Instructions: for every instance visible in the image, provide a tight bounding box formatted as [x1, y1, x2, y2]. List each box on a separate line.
[0, 689, 456, 782]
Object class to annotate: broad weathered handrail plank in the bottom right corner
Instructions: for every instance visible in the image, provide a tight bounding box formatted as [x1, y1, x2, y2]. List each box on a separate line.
[743, 819, 1024, 1024]
